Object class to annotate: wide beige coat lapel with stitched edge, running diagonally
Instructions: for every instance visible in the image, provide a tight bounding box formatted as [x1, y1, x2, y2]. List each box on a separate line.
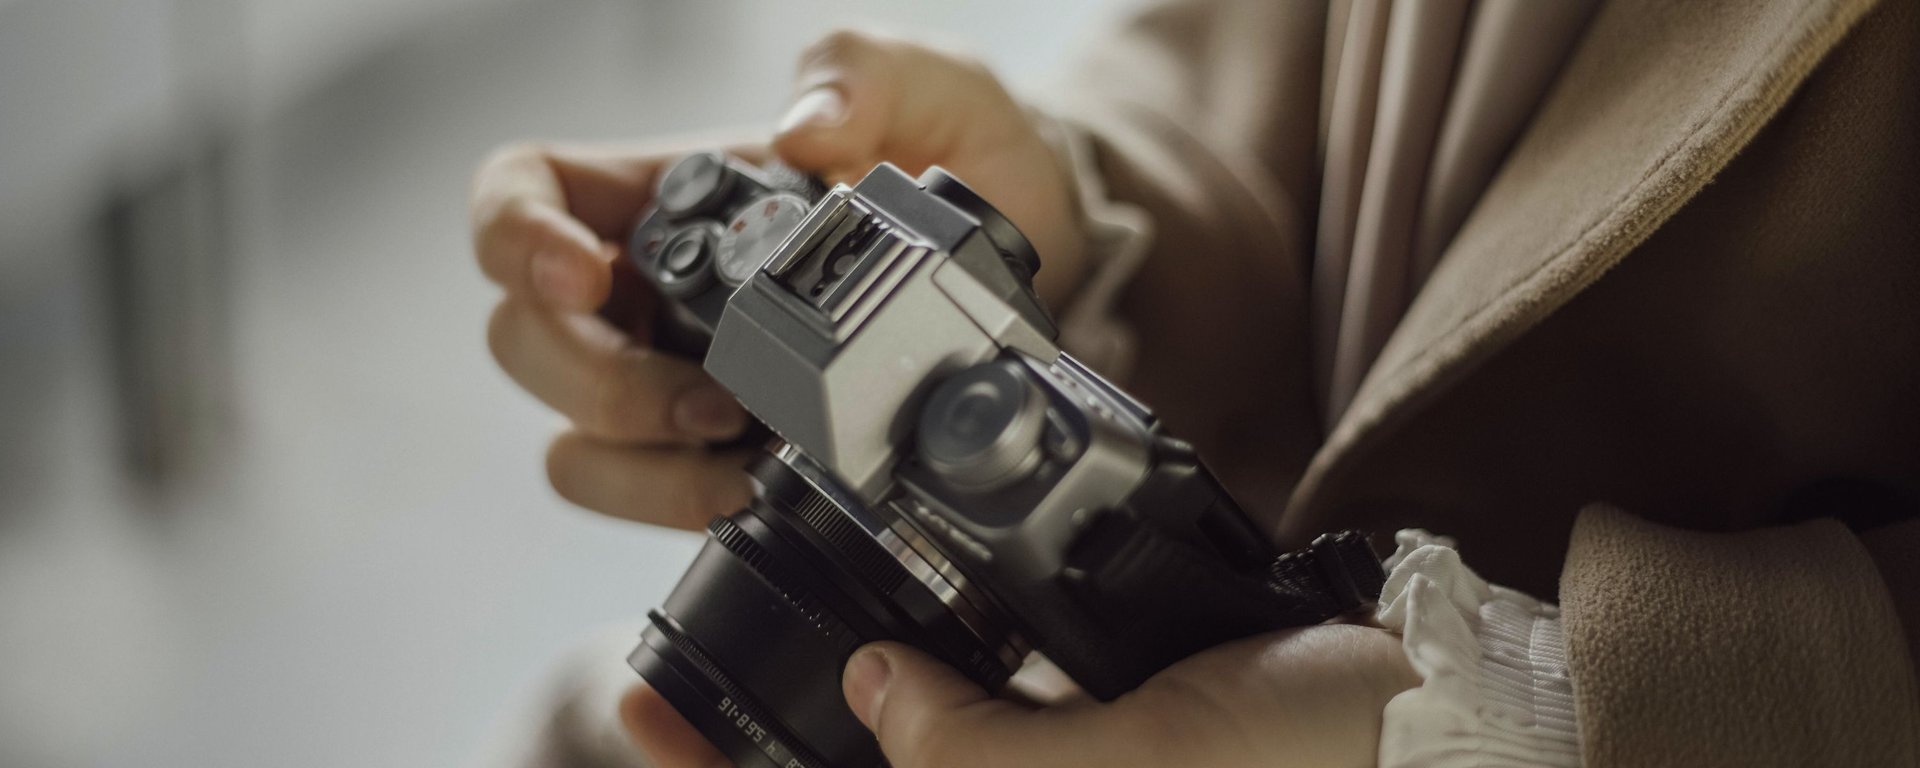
[1290, 0, 1874, 511]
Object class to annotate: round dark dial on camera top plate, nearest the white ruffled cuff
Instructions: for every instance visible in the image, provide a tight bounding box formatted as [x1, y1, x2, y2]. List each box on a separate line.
[916, 361, 1046, 492]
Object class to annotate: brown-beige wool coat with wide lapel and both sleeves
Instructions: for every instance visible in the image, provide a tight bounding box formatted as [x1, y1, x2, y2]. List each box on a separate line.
[1043, 0, 1920, 766]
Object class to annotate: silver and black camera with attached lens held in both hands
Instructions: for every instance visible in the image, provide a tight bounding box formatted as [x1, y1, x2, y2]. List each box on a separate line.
[614, 154, 1382, 766]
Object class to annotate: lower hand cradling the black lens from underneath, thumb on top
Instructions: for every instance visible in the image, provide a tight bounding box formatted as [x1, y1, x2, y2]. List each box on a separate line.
[620, 624, 1419, 768]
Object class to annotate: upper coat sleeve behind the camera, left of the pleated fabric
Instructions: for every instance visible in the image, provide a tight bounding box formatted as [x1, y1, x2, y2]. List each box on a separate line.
[1029, 0, 1327, 522]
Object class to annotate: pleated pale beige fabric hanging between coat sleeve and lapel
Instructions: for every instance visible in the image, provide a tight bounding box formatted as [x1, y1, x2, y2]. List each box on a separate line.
[1313, 0, 1594, 419]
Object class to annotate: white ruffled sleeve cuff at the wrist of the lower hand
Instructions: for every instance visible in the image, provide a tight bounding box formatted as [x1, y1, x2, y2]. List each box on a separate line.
[1375, 530, 1580, 768]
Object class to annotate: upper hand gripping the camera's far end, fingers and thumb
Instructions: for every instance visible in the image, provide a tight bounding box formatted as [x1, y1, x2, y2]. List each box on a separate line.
[470, 33, 1083, 530]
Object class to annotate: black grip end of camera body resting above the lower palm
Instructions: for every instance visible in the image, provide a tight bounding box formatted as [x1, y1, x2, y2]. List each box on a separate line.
[1006, 440, 1386, 699]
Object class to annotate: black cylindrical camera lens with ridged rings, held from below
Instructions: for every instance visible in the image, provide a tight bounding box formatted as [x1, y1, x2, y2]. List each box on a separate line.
[628, 447, 1023, 768]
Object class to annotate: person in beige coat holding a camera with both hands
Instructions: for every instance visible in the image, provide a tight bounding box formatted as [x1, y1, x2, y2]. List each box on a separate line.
[472, 0, 1920, 766]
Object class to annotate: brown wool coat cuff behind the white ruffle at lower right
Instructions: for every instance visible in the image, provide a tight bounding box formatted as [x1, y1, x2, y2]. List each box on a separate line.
[1561, 507, 1920, 766]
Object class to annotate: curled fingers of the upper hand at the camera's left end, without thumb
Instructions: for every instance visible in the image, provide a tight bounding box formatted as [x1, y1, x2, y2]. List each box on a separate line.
[470, 142, 766, 528]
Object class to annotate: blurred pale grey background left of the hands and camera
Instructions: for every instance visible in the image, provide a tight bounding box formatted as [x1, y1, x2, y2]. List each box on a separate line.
[0, 0, 1112, 768]
